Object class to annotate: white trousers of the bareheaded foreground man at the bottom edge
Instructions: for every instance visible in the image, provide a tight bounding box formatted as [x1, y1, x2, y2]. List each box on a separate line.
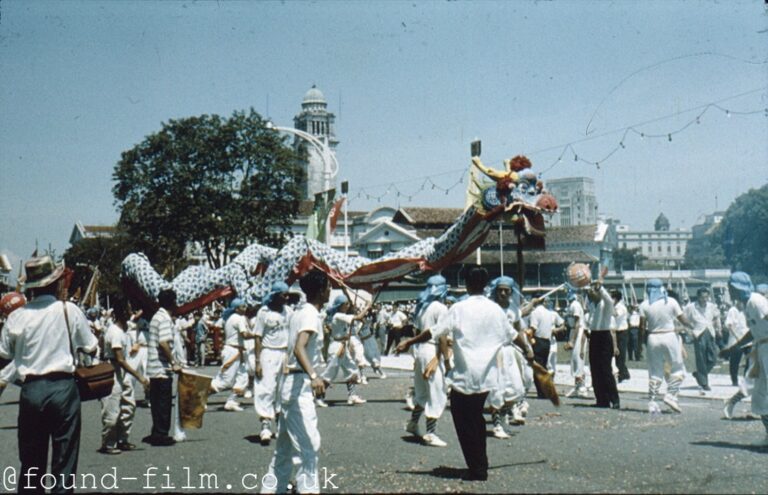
[261, 373, 320, 493]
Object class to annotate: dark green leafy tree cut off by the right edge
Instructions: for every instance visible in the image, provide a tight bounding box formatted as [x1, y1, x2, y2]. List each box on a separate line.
[720, 184, 768, 281]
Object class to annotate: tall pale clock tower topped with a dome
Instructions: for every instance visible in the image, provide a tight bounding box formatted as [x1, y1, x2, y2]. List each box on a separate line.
[293, 84, 339, 199]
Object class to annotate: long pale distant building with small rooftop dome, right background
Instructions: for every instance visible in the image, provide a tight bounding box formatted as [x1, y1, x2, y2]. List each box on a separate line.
[616, 213, 692, 267]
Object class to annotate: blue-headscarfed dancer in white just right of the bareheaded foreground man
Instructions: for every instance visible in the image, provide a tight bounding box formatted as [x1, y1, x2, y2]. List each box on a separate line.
[322, 287, 371, 406]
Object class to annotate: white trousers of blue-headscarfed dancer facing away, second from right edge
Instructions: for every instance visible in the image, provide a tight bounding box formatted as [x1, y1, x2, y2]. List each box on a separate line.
[645, 332, 685, 400]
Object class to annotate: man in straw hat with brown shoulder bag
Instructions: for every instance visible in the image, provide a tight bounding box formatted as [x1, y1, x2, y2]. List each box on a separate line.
[0, 256, 98, 492]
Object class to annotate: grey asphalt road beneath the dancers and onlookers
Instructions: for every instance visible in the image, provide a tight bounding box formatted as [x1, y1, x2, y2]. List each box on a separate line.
[0, 368, 768, 493]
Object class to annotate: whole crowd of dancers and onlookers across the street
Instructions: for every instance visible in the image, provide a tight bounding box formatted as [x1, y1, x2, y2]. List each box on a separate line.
[0, 256, 768, 493]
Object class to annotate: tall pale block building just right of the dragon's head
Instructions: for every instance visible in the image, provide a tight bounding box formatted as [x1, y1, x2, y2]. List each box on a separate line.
[546, 177, 598, 227]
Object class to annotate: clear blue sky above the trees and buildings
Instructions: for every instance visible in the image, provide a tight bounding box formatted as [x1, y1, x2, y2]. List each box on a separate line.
[0, 0, 768, 278]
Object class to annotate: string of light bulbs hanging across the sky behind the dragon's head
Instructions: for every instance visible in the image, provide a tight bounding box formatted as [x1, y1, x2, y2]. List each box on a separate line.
[349, 86, 768, 203]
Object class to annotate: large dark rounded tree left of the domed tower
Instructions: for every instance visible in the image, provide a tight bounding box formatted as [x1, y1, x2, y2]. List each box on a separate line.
[113, 109, 302, 272]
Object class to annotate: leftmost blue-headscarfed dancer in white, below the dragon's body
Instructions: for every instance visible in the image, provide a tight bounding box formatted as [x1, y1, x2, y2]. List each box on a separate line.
[211, 298, 251, 412]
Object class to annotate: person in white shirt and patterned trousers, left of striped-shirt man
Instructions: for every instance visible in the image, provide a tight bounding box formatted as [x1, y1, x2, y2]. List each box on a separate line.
[99, 301, 149, 454]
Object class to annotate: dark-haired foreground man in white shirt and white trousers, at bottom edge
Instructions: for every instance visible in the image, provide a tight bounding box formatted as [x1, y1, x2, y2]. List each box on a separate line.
[261, 270, 330, 493]
